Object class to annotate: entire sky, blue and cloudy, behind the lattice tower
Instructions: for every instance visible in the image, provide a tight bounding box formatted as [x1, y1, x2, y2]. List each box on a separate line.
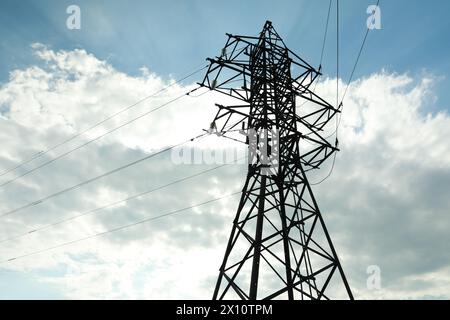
[0, 0, 450, 299]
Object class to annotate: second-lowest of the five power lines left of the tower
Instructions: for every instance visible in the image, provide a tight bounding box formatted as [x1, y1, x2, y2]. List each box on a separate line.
[0, 158, 246, 243]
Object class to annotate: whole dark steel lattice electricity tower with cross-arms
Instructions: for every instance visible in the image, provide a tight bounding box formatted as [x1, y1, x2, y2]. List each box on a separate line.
[201, 21, 353, 300]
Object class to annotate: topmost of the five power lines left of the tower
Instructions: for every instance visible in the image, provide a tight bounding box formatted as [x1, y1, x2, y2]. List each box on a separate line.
[0, 63, 208, 177]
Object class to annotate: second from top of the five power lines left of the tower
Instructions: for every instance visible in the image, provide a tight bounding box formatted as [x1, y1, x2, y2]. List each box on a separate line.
[0, 87, 204, 187]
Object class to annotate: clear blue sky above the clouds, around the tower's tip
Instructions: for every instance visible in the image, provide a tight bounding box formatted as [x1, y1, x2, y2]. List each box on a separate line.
[0, 0, 450, 106]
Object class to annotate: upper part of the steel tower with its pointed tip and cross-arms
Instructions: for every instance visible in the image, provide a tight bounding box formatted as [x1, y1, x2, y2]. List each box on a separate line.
[199, 21, 340, 169]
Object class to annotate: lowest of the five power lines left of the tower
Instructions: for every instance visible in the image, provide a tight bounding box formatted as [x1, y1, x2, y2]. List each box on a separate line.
[0, 191, 240, 264]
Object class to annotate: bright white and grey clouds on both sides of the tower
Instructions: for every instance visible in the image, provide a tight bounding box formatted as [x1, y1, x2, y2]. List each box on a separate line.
[0, 44, 450, 299]
